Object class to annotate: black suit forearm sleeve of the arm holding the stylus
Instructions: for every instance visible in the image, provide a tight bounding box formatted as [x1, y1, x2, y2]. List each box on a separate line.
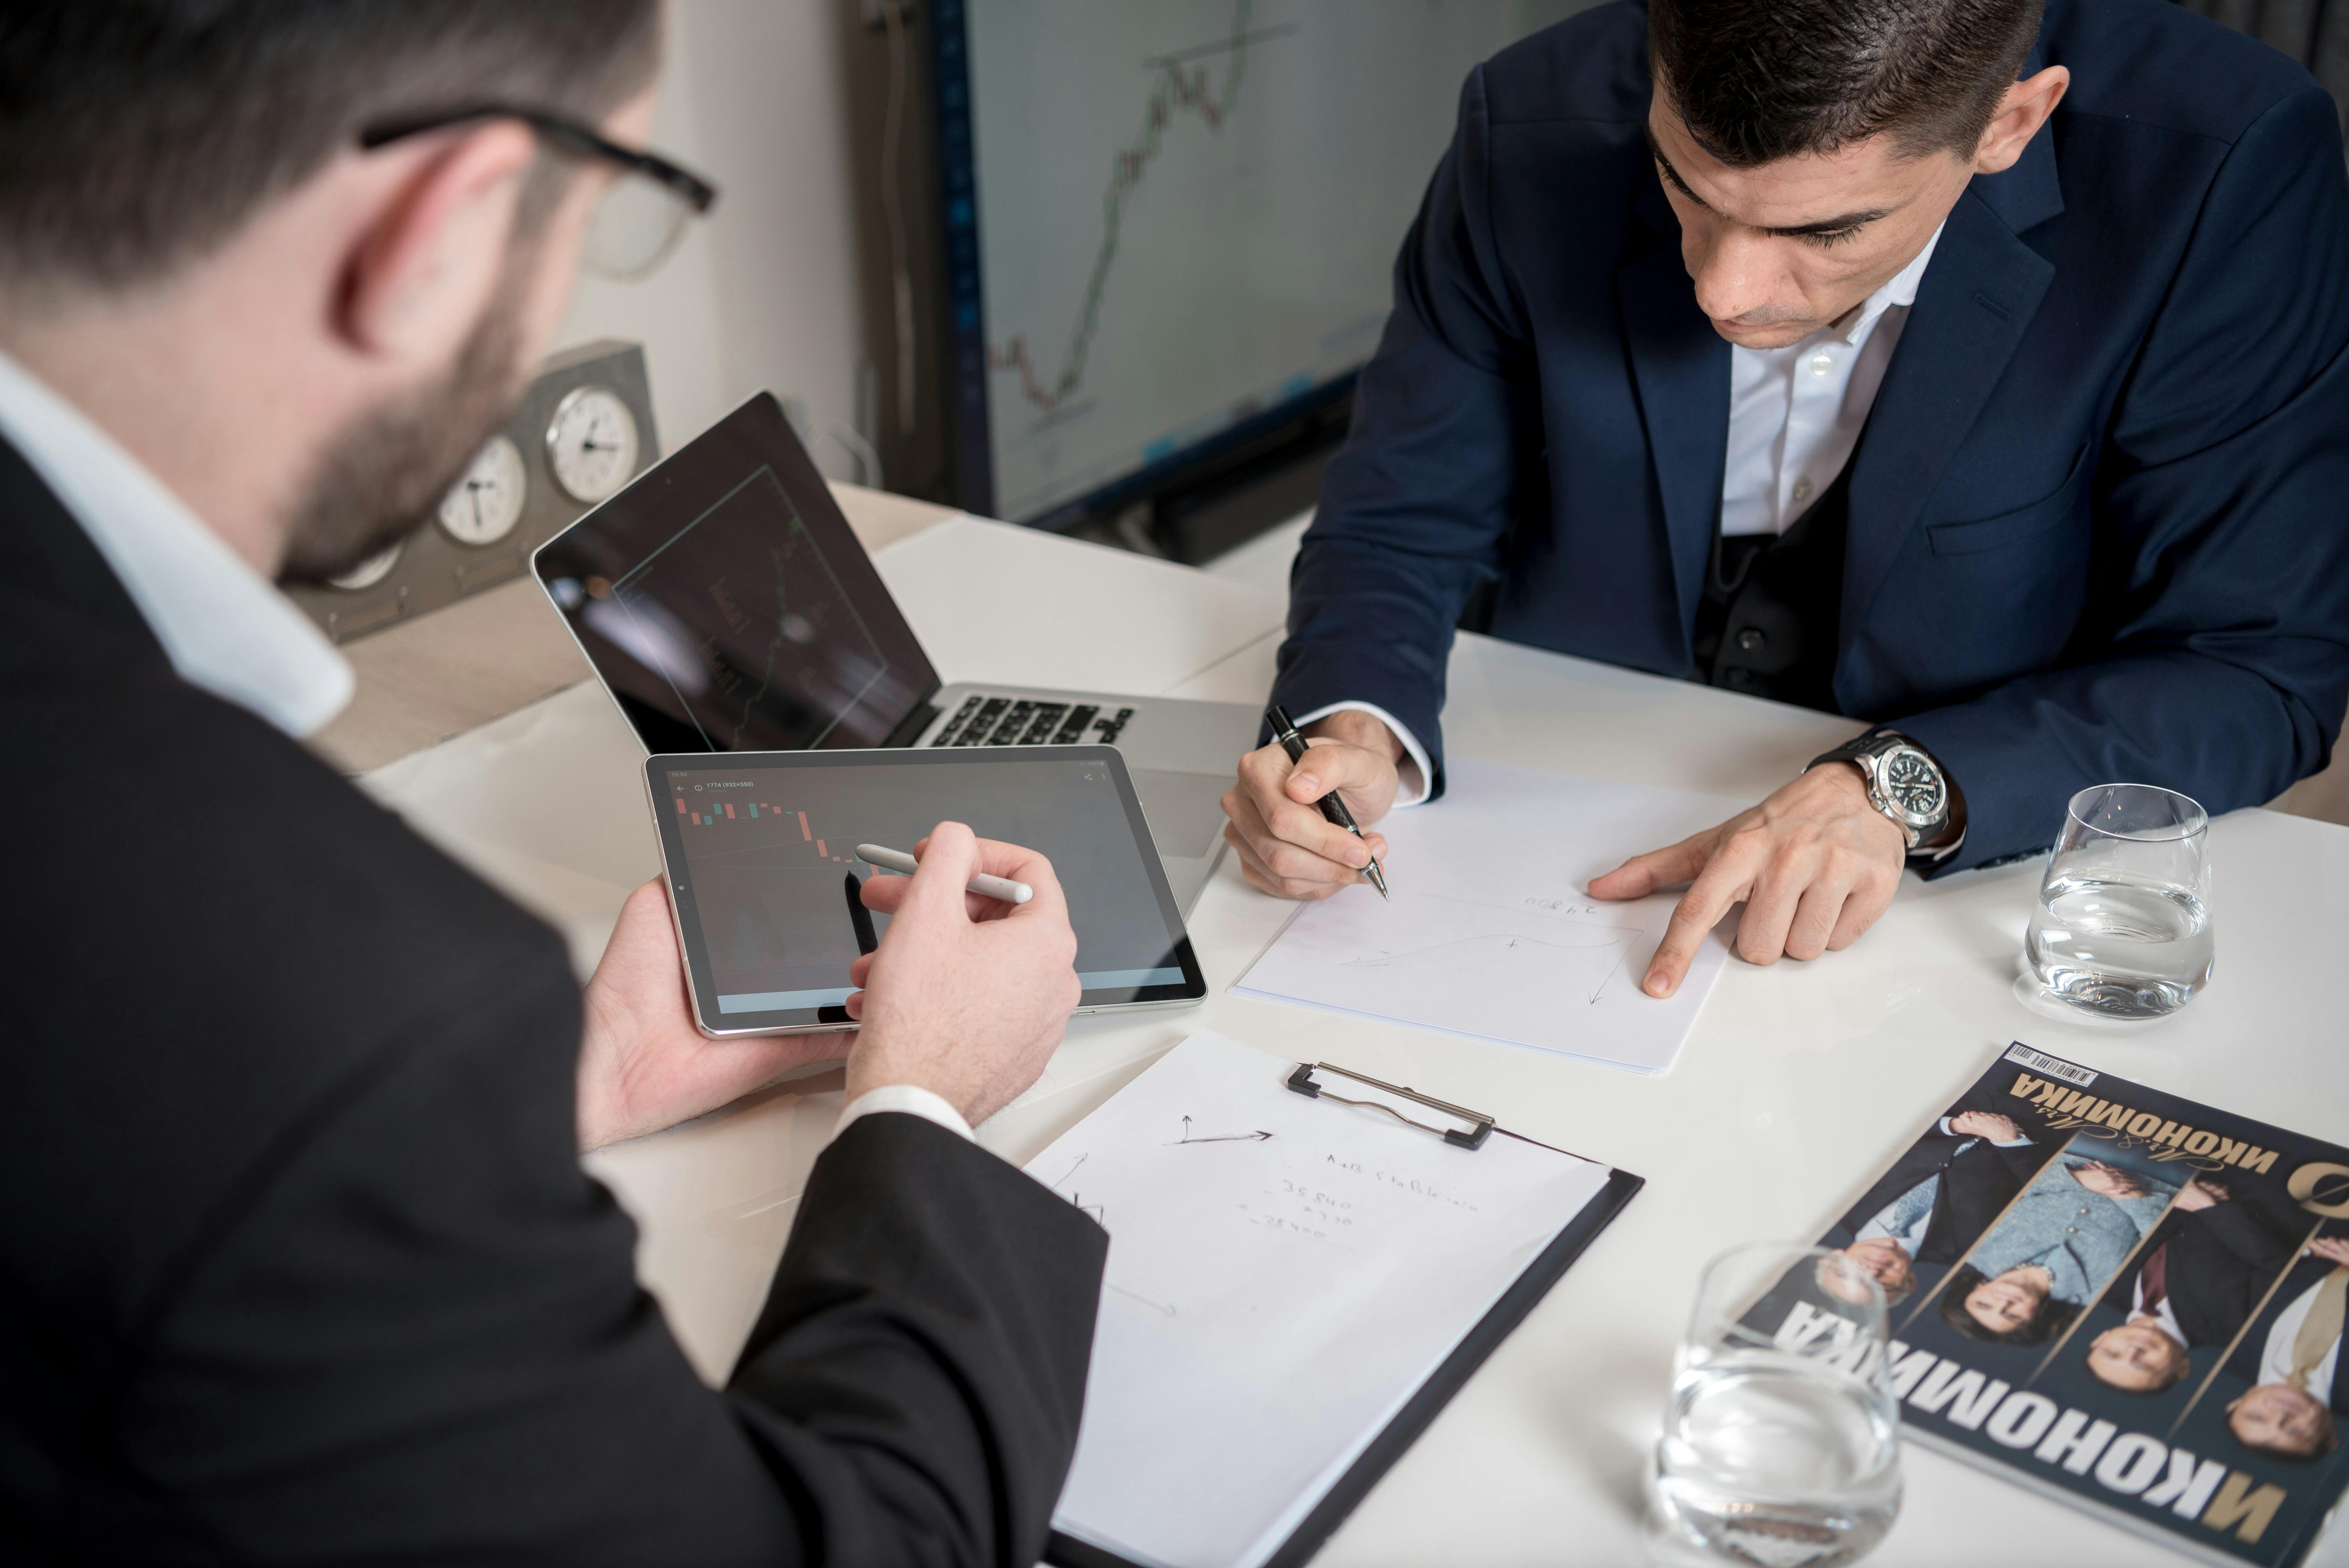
[731, 1115, 1109, 1568]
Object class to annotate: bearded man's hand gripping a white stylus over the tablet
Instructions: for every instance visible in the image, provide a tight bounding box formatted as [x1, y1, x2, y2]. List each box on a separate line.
[848, 821, 1078, 1127]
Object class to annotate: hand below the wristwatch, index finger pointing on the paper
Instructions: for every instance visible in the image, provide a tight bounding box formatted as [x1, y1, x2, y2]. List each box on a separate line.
[1590, 763, 1907, 998]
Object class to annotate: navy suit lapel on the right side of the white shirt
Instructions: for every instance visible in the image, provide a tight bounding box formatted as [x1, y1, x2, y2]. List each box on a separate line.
[1837, 122, 2062, 666]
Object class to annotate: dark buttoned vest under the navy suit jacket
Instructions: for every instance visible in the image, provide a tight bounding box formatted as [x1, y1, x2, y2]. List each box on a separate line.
[1691, 453, 1858, 714]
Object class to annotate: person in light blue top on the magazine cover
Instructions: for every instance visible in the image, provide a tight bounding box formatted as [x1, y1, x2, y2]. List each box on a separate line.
[1940, 1153, 2175, 1345]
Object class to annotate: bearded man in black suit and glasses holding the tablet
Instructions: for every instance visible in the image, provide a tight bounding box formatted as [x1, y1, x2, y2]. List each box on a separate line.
[0, 0, 1107, 1568]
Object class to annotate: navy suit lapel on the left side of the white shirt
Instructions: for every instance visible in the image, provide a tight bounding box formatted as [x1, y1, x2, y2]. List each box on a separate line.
[1616, 194, 1729, 659]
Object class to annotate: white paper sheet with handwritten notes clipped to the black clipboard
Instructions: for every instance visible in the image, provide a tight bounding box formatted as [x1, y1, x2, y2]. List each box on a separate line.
[1027, 1030, 1607, 1568]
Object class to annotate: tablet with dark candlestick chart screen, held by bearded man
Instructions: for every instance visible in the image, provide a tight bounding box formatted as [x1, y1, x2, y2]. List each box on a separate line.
[643, 747, 1207, 1037]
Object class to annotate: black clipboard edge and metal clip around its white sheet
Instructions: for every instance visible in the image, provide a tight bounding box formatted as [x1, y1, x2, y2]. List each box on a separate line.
[1043, 1042, 1647, 1568]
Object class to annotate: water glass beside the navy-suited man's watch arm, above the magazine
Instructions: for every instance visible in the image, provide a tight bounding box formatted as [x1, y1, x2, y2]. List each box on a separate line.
[2023, 784, 2215, 1019]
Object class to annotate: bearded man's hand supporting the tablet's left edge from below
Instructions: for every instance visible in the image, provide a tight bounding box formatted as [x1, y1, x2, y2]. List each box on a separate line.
[578, 878, 848, 1148]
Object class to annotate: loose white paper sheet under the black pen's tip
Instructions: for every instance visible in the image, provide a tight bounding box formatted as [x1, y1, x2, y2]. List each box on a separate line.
[1235, 761, 1738, 1073]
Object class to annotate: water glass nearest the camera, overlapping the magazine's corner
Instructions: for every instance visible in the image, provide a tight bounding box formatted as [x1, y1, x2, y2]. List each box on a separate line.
[1649, 1242, 1900, 1568]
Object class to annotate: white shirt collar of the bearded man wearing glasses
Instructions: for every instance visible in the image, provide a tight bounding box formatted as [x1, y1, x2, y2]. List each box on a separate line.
[0, 355, 352, 737]
